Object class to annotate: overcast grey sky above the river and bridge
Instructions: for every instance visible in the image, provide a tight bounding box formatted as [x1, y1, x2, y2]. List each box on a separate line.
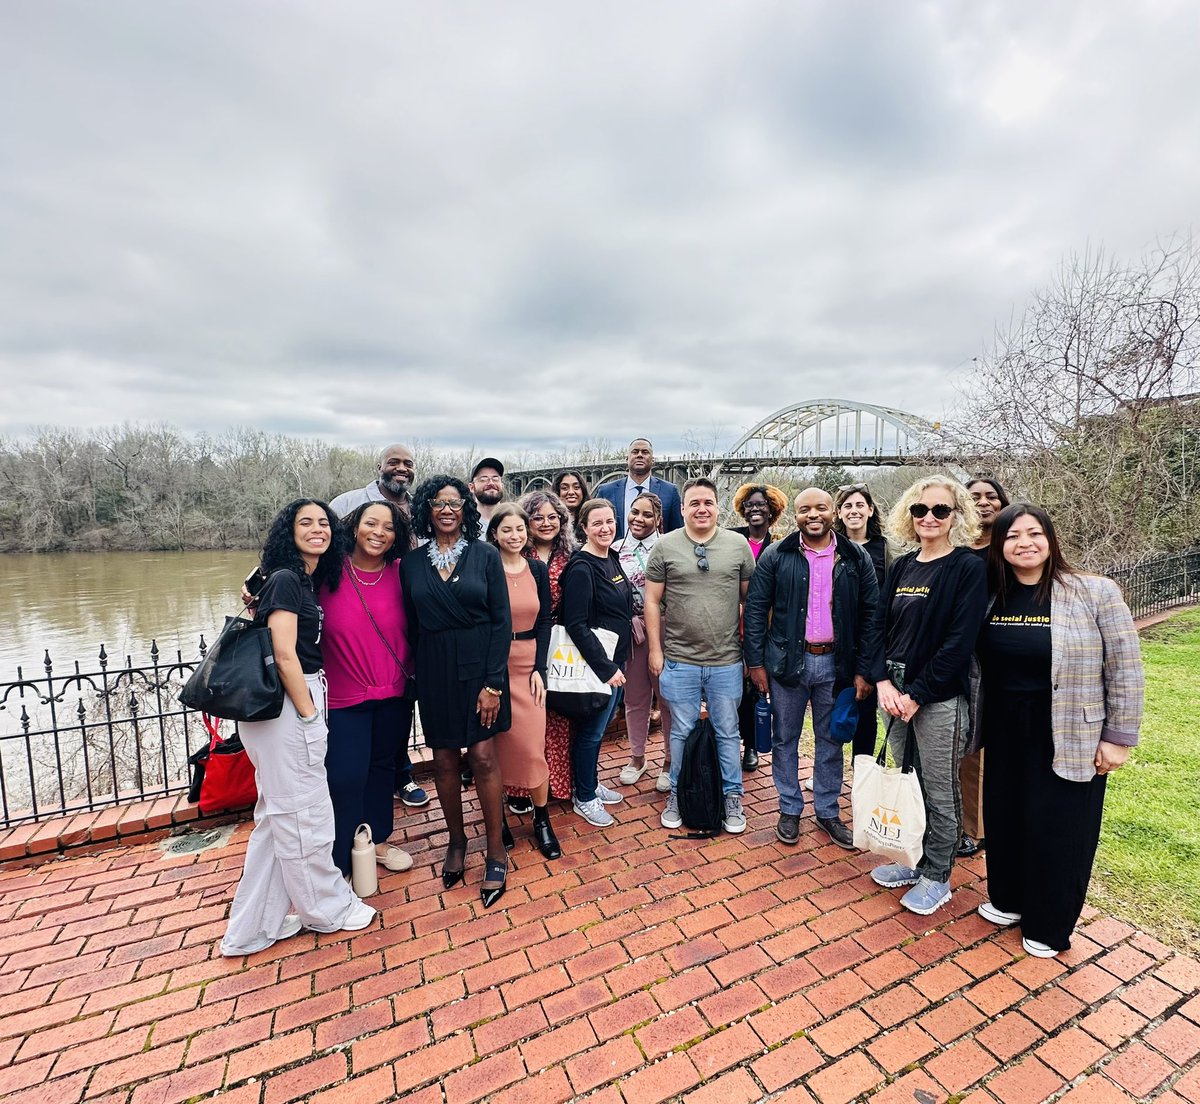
[0, 0, 1200, 456]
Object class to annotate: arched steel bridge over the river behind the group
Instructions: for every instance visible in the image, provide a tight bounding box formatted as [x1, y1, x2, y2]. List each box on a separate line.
[508, 398, 958, 494]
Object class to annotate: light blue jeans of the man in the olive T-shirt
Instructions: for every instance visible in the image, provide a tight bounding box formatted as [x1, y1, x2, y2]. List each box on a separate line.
[659, 659, 742, 793]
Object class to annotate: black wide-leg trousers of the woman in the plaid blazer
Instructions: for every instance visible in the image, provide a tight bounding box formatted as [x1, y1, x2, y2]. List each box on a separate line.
[983, 690, 1108, 950]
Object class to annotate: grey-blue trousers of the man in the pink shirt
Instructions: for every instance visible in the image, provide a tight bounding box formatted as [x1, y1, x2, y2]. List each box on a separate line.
[770, 652, 842, 820]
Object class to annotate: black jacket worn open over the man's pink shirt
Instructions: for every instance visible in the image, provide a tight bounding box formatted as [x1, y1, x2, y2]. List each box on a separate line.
[743, 533, 880, 686]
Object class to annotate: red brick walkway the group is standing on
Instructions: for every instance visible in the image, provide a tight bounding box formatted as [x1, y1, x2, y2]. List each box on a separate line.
[0, 744, 1200, 1104]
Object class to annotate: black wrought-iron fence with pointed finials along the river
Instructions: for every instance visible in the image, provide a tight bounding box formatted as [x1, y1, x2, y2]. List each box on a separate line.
[0, 548, 1200, 827]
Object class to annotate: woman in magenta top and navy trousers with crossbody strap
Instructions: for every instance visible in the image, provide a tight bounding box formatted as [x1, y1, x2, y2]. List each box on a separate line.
[317, 502, 413, 874]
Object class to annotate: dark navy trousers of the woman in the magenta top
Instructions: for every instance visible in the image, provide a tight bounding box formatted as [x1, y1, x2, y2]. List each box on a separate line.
[325, 697, 413, 874]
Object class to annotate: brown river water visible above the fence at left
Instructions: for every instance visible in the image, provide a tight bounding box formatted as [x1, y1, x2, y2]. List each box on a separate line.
[0, 551, 257, 683]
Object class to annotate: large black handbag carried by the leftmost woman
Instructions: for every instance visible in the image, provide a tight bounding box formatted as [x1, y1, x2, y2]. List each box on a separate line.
[179, 617, 283, 721]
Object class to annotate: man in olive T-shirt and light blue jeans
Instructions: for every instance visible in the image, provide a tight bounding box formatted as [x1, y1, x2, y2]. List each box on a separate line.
[646, 479, 754, 833]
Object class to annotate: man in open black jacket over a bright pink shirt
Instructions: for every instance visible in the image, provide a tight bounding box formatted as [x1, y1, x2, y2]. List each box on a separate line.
[743, 487, 880, 850]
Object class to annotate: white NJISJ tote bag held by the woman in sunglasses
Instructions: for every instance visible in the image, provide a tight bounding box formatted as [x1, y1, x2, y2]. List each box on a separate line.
[850, 730, 925, 866]
